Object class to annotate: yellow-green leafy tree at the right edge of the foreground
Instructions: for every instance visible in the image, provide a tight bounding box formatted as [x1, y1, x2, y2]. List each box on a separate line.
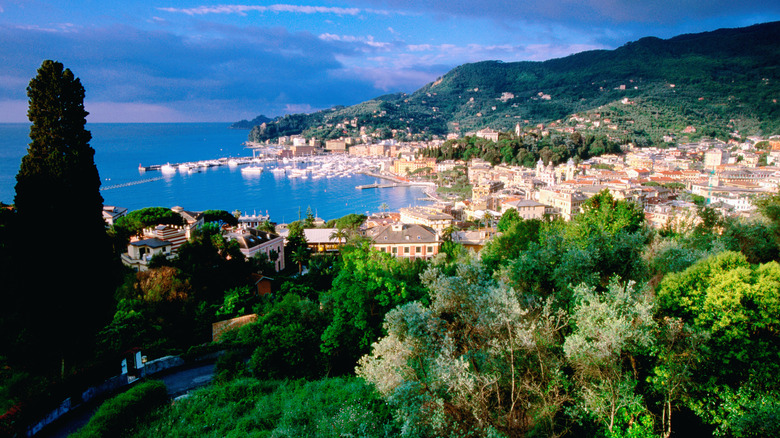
[657, 251, 780, 433]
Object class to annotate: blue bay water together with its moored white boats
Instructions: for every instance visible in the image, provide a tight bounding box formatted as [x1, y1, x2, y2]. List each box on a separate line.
[0, 123, 426, 223]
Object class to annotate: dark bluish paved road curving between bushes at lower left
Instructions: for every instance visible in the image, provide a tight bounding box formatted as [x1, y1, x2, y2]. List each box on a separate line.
[35, 363, 214, 438]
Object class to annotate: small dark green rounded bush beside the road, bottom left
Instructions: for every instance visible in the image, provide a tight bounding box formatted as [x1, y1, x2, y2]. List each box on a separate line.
[71, 380, 168, 438]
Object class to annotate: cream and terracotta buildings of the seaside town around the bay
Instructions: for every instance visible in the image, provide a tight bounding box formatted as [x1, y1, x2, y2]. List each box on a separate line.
[109, 123, 780, 272]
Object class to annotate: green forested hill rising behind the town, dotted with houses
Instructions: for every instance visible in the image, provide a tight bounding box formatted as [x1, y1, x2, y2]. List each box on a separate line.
[245, 22, 780, 141]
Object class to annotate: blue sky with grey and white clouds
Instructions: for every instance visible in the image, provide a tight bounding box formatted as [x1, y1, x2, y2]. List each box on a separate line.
[0, 0, 780, 123]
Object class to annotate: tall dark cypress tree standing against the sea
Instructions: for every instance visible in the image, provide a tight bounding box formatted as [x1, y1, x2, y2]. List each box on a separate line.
[3, 60, 117, 374]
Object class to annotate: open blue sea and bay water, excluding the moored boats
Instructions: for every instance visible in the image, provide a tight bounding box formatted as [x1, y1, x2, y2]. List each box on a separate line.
[0, 123, 427, 223]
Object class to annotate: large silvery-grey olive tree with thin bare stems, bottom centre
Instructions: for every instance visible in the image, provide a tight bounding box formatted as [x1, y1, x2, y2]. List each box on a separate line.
[357, 259, 570, 437]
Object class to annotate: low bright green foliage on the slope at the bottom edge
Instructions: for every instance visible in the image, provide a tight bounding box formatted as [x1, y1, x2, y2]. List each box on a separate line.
[132, 377, 398, 438]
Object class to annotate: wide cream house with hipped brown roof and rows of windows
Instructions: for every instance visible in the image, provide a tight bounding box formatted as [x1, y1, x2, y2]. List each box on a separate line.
[366, 223, 441, 259]
